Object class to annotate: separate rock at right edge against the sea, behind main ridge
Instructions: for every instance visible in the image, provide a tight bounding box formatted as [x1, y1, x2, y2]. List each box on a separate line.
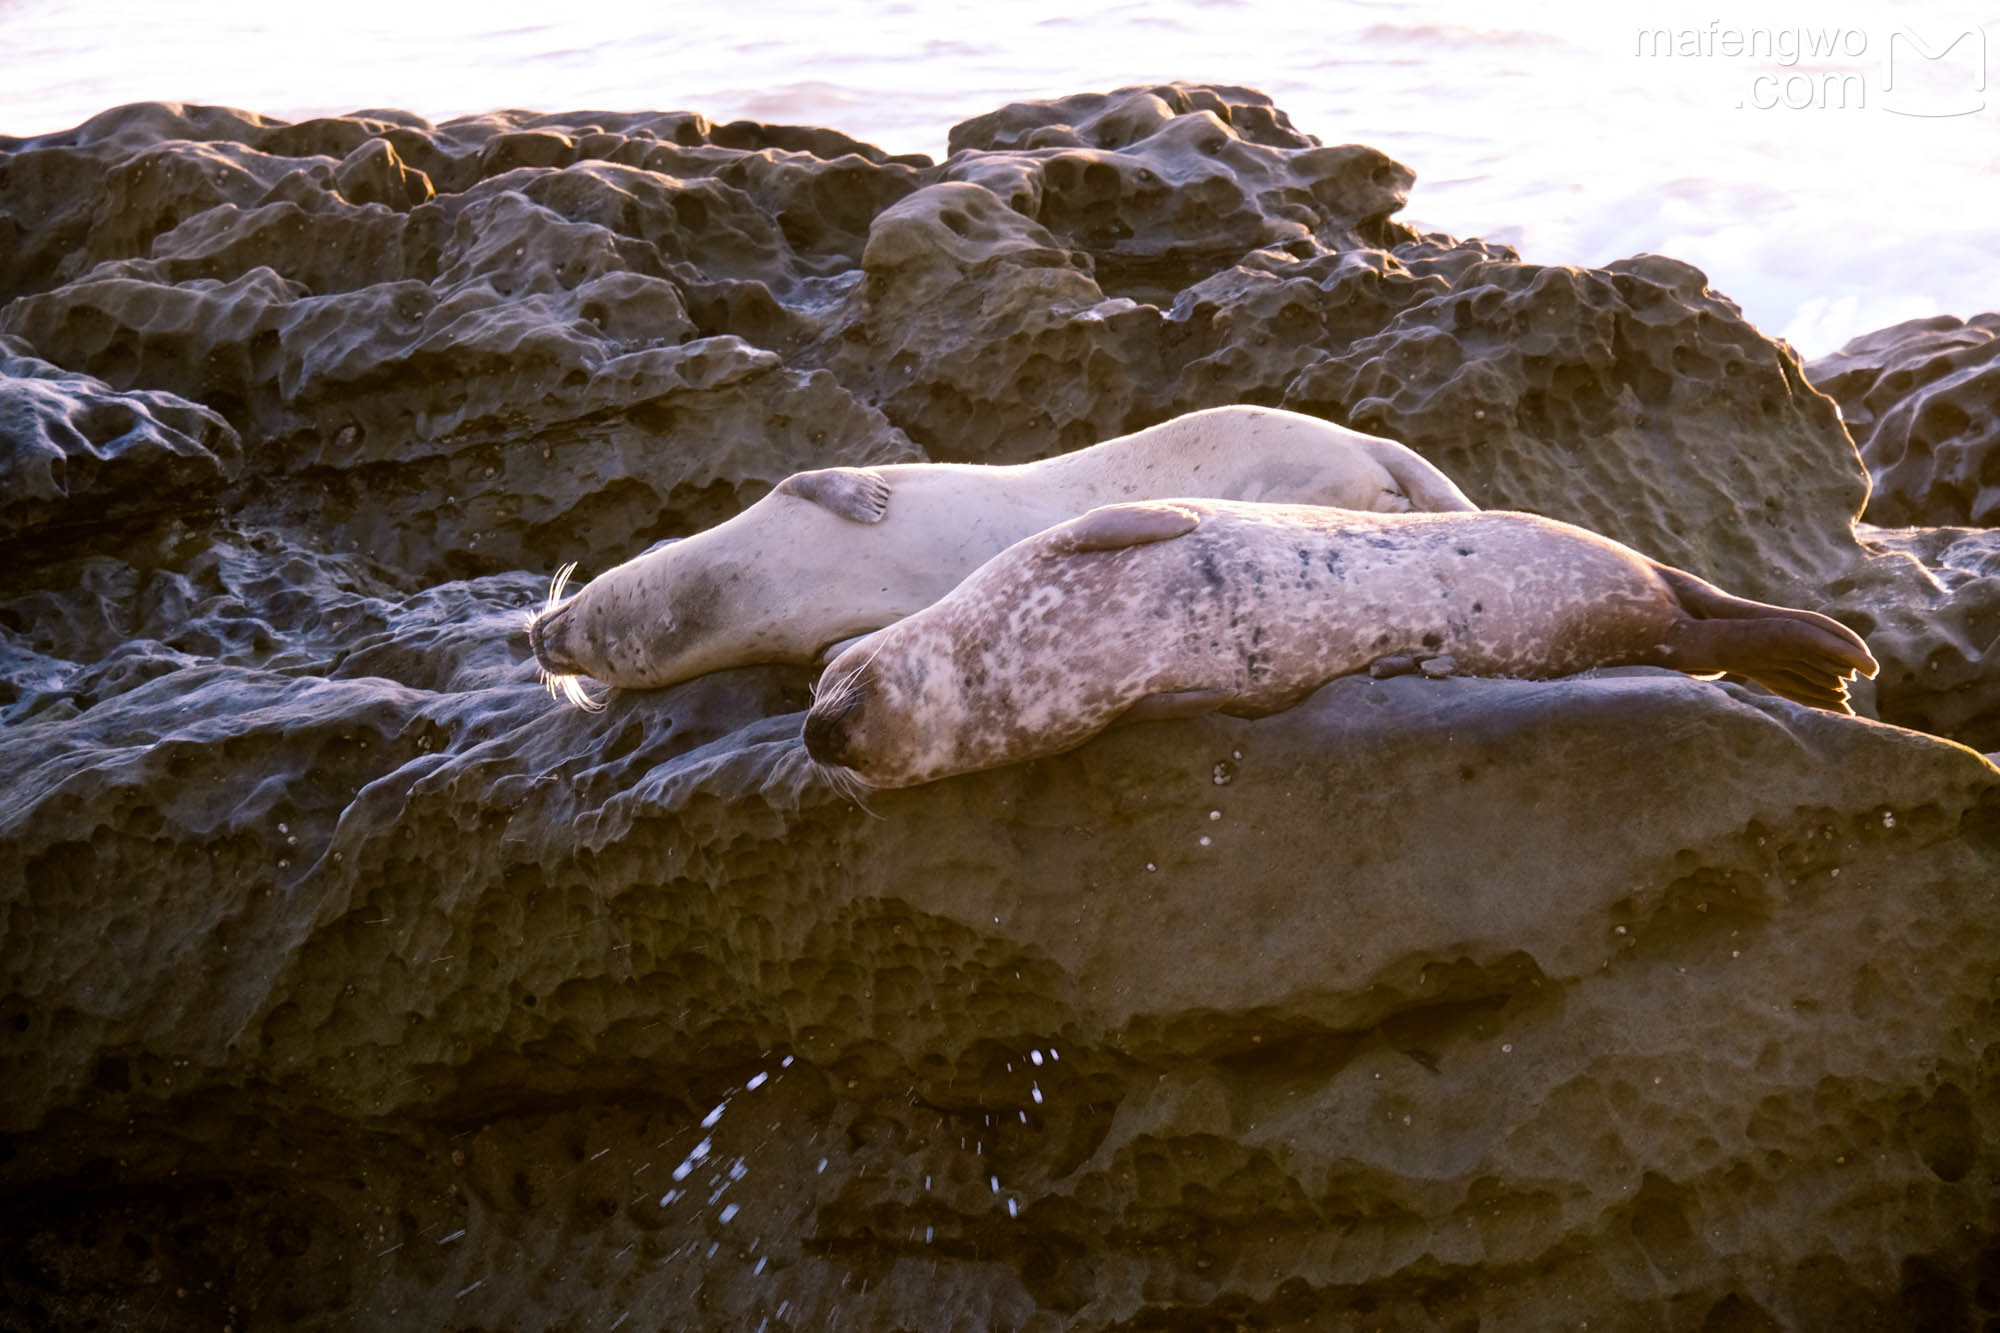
[1806, 314, 2000, 526]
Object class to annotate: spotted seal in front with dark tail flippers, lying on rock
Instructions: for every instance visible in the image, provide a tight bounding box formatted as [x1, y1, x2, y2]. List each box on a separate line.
[804, 500, 1876, 787]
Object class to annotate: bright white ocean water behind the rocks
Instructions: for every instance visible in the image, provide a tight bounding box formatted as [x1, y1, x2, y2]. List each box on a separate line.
[0, 0, 2000, 356]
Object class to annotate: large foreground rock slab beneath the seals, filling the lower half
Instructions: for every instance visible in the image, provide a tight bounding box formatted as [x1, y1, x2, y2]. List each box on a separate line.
[0, 656, 2000, 1327]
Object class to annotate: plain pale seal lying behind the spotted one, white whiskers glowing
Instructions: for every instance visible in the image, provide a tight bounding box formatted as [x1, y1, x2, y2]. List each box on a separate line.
[528, 406, 1476, 703]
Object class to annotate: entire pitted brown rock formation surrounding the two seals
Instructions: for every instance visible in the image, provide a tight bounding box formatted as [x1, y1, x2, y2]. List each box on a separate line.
[0, 84, 2000, 1329]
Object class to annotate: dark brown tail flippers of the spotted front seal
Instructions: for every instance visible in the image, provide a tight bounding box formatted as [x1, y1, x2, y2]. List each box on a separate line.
[1656, 564, 1878, 713]
